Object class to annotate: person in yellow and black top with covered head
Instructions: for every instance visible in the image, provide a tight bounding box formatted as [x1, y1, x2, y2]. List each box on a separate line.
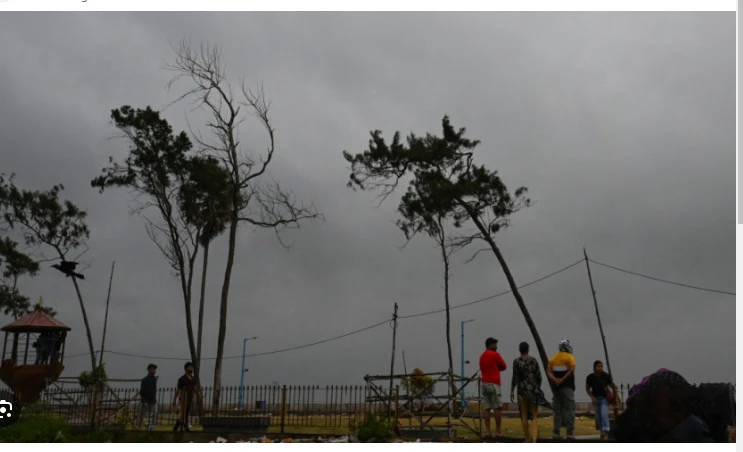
[547, 339, 575, 440]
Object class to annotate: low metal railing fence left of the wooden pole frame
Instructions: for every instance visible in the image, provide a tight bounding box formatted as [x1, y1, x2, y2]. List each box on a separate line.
[37, 385, 370, 433]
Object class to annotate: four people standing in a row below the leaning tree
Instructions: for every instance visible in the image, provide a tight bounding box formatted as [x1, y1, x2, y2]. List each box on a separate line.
[480, 337, 617, 442]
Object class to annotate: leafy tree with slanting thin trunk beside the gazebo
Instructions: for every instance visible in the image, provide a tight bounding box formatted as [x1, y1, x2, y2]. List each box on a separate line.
[0, 175, 96, 369]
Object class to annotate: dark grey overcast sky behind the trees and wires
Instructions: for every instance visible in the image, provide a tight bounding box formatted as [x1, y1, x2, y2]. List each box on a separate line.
[0, 13, 735, 398]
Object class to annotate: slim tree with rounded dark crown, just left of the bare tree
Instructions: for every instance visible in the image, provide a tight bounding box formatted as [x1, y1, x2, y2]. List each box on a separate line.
[178, 156, 232, 376]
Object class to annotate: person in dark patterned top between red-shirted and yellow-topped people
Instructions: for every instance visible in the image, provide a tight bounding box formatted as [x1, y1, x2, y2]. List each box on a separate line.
[511, 342, 551, 443]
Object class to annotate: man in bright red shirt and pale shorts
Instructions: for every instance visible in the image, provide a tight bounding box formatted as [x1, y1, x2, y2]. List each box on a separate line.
[480, 337, 506, 438]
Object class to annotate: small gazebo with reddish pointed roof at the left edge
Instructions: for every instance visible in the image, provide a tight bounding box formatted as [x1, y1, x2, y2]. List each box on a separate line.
[0, 300, 71, 404]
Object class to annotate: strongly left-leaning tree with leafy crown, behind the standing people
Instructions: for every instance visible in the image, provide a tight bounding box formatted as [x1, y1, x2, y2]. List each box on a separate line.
[343, 116, 547, 369]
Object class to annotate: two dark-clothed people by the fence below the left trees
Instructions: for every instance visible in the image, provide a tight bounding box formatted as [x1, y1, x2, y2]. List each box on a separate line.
[137, 361, 202, 432]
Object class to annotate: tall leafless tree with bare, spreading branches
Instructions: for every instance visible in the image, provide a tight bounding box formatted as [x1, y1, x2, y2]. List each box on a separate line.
[169, 40, 322, 413]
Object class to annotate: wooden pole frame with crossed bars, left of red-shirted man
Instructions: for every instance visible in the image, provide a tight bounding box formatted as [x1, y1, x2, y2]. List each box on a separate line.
[364, 371, 482, 438]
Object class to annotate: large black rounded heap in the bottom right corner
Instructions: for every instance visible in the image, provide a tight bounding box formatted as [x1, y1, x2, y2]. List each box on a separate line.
[615, 369, 735, 443]
